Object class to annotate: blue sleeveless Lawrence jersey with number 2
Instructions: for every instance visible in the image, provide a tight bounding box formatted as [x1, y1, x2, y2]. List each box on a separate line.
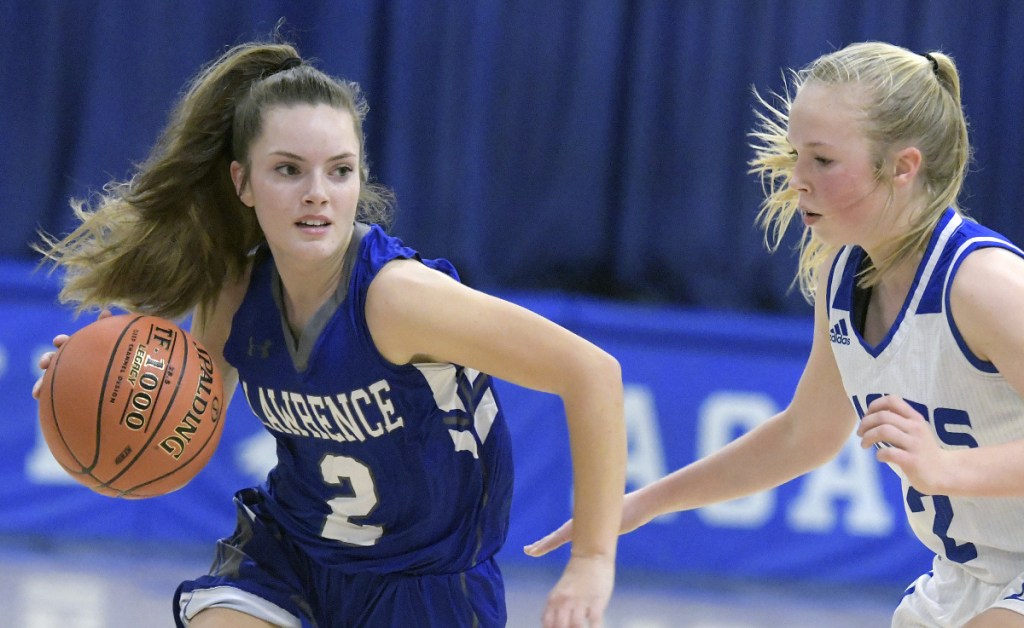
[224, 223, 512, 574]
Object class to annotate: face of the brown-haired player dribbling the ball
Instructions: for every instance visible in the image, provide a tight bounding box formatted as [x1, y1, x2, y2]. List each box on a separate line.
[231, 104, 359, 266]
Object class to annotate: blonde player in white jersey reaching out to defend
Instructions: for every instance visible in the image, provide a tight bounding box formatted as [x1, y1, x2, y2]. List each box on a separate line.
[526, 42, 1024, 628]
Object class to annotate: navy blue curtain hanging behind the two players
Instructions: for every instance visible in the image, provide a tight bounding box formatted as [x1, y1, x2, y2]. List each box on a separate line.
[0, 0, 1024, 315]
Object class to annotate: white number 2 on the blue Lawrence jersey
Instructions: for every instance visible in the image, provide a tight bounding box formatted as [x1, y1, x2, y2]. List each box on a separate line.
[321, 456, 384, 547]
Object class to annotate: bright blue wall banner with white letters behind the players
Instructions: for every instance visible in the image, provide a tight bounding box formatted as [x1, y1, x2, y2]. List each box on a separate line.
[0, 259, 930, 587]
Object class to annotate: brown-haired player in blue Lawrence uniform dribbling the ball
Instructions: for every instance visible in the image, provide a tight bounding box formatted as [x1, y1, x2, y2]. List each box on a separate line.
[29, 44, 626, 628]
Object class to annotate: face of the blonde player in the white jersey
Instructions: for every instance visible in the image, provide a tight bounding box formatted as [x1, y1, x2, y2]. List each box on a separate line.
[788, 83, 892, 248]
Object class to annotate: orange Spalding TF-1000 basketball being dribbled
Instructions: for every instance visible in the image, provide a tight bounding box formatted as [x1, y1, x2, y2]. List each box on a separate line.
[39, 315, 224, 499]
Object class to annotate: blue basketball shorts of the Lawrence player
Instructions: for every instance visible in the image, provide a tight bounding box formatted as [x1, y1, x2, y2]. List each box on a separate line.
[174, 489, 507, 628]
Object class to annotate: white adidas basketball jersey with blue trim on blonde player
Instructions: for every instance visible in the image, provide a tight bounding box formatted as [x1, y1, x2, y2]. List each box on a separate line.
[826, 209, 1024, 583]
